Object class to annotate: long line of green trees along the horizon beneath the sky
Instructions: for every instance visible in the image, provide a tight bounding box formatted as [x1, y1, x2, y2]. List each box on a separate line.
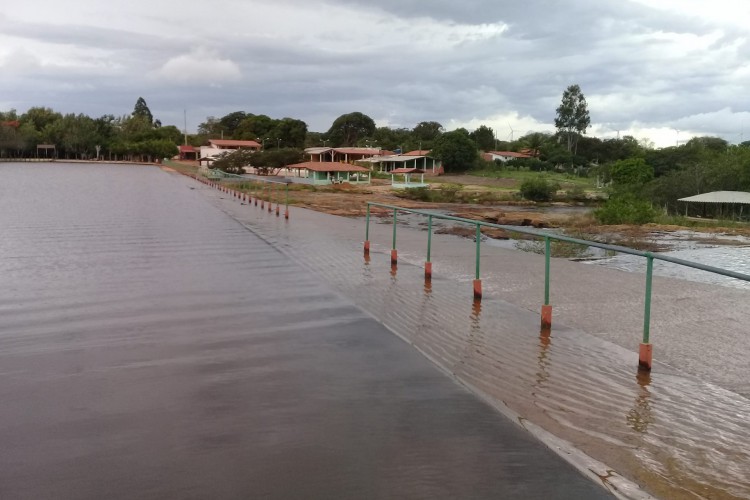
[5, 89, 750, 221]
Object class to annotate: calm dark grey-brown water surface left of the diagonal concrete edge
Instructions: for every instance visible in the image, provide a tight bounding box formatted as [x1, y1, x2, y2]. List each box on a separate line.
[0, 166, 609, 499]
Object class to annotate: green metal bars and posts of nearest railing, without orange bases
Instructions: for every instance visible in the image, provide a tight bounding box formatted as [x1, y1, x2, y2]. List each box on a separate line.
[365, 202, 750, 368]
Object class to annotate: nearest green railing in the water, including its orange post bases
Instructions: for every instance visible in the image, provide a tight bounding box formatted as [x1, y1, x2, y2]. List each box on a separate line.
[364, 201, 750, 370]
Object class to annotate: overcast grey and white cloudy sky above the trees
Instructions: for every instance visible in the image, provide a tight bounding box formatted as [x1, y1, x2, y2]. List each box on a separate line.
[0, 0, 750, 146]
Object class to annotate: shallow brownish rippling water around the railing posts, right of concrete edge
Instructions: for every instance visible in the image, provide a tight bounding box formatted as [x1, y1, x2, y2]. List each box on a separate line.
[212, 179, 750, 498]
